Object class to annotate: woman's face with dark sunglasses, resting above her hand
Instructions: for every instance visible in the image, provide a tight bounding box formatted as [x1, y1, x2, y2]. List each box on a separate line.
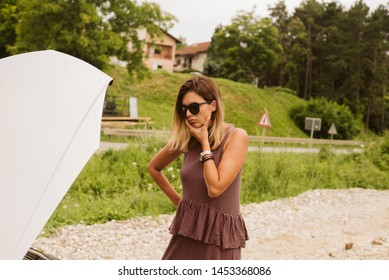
[181, 91, 216, 128]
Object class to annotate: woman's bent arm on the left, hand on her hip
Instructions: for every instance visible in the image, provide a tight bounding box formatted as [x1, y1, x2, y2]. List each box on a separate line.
[147, 146, 181, 207]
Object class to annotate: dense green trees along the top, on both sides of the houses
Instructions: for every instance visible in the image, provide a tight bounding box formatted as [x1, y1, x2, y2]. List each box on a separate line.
[0, 0, 389, 133]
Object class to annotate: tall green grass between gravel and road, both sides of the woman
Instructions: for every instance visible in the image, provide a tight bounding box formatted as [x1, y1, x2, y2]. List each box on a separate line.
[44, 138, 389, 234]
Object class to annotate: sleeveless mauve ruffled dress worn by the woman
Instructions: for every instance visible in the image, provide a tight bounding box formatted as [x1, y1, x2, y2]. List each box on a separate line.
[162, 126, 248, 260]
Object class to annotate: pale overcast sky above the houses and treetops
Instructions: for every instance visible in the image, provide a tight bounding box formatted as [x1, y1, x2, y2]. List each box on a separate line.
[138, 0, 389, 44]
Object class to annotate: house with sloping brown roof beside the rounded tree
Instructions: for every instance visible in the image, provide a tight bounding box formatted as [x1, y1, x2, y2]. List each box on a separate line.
[174, 42, 211, 72]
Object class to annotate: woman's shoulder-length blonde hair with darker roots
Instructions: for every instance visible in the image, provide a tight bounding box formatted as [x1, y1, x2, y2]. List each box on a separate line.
[168, 75, 224, 153]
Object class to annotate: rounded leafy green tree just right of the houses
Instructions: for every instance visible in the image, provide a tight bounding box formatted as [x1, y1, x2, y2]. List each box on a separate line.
[205, 9, 282, 86]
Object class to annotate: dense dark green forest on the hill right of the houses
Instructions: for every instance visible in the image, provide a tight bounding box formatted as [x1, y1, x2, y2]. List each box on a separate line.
[206, 0, 389, 132]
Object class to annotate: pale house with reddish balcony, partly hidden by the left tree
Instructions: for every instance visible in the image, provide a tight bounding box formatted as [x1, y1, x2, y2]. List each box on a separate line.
[139, 30, 180, 72]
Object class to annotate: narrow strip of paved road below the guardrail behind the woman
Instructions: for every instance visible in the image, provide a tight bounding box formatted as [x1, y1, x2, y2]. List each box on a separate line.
[97, 142, 363, 154]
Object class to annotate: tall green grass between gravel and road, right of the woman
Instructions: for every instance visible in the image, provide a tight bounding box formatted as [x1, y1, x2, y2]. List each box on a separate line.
[242, 144, 389, 203]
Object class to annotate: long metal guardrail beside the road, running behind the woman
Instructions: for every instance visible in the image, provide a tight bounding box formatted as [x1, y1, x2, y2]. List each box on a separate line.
[102, 128, 365, 147]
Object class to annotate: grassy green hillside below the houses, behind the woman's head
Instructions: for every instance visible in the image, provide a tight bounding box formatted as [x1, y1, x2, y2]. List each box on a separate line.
[106, 66, 306, 137]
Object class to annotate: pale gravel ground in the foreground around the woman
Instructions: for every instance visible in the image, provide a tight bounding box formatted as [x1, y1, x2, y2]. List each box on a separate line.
[32, 189, 389, 260]
